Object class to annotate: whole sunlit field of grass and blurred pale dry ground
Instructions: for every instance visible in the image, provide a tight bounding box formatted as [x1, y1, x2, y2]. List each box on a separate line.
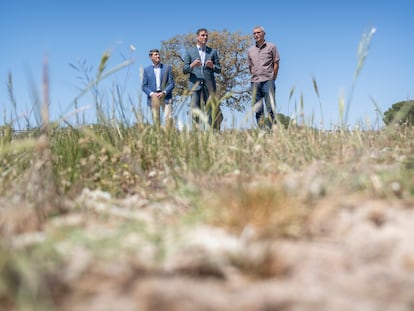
[0, 28, 414, 311]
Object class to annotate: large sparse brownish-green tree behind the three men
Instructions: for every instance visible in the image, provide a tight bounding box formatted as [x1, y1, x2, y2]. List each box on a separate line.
[160, 30, 251, 111]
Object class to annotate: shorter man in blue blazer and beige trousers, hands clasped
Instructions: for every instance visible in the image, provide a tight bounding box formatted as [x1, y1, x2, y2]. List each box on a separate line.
[142, 49, 175, 126]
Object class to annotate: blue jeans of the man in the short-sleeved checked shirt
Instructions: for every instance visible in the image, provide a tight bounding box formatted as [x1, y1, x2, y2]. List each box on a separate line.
[251, 80, 276, 125]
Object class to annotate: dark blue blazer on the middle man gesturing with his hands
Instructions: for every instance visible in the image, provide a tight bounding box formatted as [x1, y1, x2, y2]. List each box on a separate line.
[183, 46, 221, 92]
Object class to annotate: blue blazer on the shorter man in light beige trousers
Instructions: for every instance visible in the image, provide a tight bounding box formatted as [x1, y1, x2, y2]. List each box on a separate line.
[142, 64, 175, 106]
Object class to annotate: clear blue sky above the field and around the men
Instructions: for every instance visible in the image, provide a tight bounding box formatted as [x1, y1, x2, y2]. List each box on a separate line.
[0, 0, 414, 128]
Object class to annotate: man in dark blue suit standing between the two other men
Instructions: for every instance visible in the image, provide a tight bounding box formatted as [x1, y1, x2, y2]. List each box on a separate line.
[183, 28, 221, 128]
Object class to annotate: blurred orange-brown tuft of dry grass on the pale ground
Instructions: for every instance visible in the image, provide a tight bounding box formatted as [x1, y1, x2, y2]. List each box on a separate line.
[201, 176, 307, 238]
